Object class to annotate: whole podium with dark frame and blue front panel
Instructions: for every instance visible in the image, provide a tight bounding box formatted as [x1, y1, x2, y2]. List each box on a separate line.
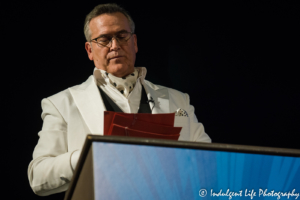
[65, 135, 300, 200]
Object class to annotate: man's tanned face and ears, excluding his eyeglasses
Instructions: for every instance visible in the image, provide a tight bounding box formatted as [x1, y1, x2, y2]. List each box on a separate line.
[85, 12, 138, 77]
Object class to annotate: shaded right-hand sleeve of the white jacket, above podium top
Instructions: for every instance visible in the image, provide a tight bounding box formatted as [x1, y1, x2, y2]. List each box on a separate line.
[185, 93, 211, 143]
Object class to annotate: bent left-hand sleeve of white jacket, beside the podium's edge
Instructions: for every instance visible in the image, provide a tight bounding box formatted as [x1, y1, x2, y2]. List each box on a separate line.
[28, 99, 73, 196]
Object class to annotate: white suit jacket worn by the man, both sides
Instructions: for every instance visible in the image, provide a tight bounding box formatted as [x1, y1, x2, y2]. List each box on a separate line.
[28, 75, 211, 196]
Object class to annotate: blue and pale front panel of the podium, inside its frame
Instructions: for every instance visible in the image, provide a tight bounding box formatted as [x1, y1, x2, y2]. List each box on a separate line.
[92, 141, 300, 200]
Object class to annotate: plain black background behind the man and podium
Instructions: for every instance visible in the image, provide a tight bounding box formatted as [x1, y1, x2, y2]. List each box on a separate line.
[0, 0, 300, 200]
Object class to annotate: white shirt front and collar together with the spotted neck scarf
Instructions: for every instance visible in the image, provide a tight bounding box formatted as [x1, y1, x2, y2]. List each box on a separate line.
[94, 67, 147, 113]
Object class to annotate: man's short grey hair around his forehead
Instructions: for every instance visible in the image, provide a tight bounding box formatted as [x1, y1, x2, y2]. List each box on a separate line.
[83, 3, 135, 42]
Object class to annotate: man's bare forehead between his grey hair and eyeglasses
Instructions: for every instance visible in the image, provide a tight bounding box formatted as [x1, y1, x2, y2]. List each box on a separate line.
[90, 12, 130, 35]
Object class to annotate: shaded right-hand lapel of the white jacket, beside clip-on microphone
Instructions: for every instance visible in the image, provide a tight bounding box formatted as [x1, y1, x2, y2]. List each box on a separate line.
[142, 80, 170, 114]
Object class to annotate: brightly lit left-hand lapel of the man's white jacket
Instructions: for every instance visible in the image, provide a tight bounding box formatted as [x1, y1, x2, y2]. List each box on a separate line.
[69, 76, 106, 135]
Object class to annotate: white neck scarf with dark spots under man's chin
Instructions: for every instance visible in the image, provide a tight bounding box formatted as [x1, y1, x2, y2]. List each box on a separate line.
[101, 69, 139, 98]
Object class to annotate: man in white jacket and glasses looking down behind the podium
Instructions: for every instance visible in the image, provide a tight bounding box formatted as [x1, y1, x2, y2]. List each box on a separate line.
[28, 4, 211, 196]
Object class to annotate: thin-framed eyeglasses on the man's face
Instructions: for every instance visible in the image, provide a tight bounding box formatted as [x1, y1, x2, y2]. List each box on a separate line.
[91, 31, 133, 47]
